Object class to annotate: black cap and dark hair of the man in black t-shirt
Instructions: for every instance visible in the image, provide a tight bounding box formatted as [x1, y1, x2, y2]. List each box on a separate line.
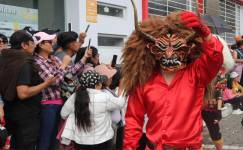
[9, 30, 34, 49]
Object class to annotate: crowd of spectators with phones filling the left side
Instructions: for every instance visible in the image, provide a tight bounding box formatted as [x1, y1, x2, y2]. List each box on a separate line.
[0, 27, 125, 150]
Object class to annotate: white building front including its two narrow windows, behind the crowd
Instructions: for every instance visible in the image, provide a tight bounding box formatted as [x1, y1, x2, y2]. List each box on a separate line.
[65, 0, 142, 63]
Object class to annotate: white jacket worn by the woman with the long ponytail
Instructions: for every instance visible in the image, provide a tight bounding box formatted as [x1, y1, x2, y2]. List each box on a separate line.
[61, 89, 125, 145]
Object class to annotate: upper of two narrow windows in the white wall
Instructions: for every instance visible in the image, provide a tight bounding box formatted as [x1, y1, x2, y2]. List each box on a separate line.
[97, 3, 124, 18]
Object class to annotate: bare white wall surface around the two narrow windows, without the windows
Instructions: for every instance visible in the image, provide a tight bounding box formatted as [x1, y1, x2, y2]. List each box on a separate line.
[65, 0, 142, 63]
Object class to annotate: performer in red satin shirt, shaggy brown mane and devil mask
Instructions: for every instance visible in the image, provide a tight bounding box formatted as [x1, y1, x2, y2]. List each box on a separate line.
[123, 0, 223, 150]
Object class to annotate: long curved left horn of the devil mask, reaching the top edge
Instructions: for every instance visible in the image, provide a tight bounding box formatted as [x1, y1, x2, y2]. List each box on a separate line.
[131, 0, 156, 43]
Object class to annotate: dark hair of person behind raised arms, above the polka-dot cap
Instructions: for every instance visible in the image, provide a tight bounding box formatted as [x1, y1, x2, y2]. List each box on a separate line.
[74, 46, 99, 65]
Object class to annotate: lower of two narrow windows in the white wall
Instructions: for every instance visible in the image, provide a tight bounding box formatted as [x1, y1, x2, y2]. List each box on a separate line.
[98, 34, 125, 47]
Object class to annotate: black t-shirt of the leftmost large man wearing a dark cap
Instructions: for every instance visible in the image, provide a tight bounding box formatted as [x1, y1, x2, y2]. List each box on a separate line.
[4, 63, 42, 120]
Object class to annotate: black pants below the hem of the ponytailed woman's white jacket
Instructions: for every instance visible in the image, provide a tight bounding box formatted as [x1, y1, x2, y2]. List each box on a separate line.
[75, 140, 112, 150]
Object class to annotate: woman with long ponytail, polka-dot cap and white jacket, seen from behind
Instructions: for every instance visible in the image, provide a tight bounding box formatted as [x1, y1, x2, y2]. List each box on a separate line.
[61, 71, 125, 150]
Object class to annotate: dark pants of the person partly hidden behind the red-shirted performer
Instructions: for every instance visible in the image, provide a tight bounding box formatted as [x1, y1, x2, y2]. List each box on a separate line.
[202, 110, 222, 141]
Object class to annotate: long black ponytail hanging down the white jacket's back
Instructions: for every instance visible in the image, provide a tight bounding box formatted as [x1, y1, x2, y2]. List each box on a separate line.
[74, 89, 91, 132]
